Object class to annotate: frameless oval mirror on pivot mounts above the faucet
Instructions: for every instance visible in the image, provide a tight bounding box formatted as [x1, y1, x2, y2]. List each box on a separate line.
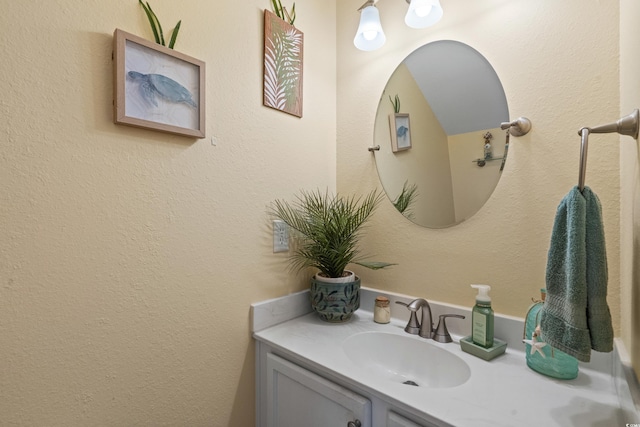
[374, 40, 509, 228]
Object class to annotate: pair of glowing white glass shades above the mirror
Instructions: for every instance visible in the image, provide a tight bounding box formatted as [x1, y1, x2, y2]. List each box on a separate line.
[353, 0, 443, 51]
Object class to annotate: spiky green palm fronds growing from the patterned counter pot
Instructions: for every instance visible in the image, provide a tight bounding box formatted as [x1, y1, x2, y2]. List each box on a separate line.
[271, 190, 393, 278]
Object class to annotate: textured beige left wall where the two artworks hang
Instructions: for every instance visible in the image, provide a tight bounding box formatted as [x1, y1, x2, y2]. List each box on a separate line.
[0, 0, 336, 427]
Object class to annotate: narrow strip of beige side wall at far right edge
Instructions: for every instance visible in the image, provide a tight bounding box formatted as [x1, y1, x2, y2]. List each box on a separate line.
[620, 0, 640, 377]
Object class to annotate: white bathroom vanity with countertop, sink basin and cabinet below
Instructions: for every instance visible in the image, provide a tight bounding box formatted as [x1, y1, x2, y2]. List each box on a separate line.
[252, 288, 640, 427]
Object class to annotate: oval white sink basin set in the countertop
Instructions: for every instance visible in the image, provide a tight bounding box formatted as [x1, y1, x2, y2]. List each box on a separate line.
[342, 332, 471, 388]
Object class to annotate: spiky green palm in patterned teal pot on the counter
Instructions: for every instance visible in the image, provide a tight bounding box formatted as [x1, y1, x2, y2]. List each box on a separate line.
[270, 190, 393, 322]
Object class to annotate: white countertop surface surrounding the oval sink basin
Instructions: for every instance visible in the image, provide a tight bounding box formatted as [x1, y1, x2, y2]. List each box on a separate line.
[254, 292, 638, 427]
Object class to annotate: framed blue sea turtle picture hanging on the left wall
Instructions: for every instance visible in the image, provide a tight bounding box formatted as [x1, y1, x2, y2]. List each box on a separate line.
[113, 30, 205, 138]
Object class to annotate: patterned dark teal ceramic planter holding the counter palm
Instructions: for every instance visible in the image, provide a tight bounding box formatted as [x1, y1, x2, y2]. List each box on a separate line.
[310, 274, 360, 323]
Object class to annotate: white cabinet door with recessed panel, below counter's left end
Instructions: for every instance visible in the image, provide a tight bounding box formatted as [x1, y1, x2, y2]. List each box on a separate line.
[267, 353, 371, 427]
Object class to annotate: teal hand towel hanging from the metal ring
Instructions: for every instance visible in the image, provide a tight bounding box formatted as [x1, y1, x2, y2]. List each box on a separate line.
[540, 186, 613, 362]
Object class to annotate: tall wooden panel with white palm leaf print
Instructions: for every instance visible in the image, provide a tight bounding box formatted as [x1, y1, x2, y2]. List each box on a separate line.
[264, 10, 304, 117]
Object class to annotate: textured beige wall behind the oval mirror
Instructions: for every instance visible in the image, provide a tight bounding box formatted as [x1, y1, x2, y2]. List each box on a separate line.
[337, 0, 627, 333]
